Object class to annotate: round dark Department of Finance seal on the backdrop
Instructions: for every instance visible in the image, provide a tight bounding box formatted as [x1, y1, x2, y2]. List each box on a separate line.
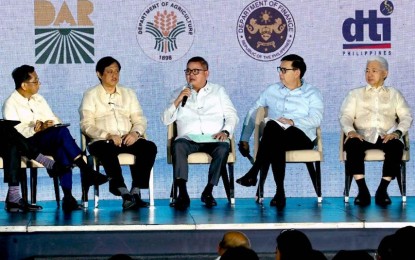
[236, 0, 295, 61]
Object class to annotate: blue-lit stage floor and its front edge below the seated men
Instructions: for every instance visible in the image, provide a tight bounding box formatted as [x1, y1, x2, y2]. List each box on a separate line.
[0, 197, 415, 259]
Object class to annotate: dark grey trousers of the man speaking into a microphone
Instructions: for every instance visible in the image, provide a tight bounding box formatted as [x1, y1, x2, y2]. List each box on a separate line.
[172, 138, 230, 186]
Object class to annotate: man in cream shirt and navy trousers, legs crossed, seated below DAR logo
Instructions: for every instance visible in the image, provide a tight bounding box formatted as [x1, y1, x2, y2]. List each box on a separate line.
[3, 65, 108, 211]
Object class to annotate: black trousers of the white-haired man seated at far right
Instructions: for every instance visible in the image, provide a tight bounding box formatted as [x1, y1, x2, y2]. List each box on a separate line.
[344, 137, 404, 178]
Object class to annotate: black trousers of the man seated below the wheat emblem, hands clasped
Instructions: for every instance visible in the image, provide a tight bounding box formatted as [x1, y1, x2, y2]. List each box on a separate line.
[88, 139, 157, 195]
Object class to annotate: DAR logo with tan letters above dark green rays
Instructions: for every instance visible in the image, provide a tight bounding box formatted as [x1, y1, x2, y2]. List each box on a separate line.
[34, 0, 94, 64]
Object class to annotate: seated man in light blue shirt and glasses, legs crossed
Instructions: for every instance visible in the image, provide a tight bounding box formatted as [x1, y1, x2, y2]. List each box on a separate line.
[236, 54, 324, 209]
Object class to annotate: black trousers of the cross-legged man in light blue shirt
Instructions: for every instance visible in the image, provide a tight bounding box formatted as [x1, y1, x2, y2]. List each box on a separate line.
[255, 120, 314, 188]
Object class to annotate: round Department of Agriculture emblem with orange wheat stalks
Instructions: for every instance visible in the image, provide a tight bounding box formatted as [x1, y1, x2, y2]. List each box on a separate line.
[136, 1, 195, 62]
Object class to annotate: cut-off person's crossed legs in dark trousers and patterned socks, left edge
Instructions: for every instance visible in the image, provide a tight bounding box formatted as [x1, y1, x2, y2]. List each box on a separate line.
[0, 121, 65, 212]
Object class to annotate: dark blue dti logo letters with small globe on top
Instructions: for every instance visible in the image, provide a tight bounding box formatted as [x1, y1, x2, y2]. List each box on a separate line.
[343, 0, 394, 49]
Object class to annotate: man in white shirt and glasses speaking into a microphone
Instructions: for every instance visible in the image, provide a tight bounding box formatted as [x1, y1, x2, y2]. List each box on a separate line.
[162, 57, 239, 210]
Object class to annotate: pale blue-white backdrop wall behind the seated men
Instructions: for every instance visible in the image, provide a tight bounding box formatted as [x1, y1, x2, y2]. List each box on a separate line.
[0, 0, 415, 199]
